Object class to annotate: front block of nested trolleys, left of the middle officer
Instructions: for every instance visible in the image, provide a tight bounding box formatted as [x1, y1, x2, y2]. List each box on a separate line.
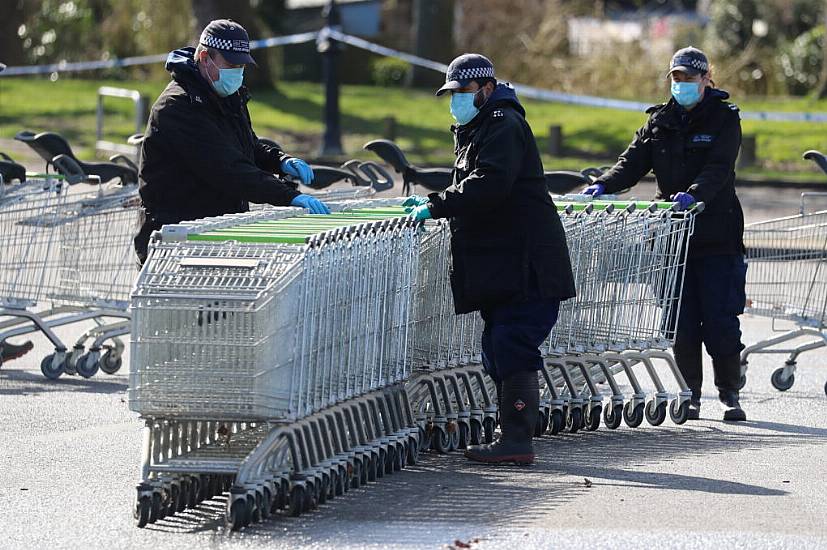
[129, 207, 426, 527]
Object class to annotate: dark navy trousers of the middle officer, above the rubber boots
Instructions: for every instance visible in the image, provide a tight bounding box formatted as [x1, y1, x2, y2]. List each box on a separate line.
[480, 299, 560, 383]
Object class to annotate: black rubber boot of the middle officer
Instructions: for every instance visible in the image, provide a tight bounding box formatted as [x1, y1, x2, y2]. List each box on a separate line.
[465, 371, 540, 464]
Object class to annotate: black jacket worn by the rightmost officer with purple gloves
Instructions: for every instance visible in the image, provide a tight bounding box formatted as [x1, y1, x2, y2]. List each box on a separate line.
[597, 88, 744, 258]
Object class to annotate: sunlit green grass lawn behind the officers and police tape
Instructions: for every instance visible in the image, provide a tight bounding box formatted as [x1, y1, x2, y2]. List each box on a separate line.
[0, 77, 827, 180]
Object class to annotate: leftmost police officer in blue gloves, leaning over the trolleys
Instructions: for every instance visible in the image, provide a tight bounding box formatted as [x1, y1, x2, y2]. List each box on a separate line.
[135, 19, 329, 263]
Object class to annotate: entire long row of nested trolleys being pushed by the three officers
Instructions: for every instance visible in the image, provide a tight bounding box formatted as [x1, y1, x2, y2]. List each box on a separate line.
[129, 198, 695, 529]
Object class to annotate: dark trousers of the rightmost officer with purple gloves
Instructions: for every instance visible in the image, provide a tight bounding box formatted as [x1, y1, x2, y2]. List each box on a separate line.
[674, 254, 747, 399]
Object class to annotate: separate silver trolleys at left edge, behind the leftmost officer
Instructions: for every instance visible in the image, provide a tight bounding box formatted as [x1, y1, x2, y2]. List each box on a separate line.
[0, 174, 139, 379]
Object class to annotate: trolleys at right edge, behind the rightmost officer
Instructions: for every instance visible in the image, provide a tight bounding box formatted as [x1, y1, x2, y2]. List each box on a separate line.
[741, 201, 827, 393]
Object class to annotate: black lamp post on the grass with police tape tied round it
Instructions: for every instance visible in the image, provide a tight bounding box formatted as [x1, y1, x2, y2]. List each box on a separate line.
[316, 0, 344, 157]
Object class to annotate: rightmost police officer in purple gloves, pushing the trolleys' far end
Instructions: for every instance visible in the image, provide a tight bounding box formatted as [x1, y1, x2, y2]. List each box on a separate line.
[584, 47, 746, 421]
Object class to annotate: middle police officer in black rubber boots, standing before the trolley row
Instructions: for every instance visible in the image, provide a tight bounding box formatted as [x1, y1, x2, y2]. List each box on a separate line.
[406, 54, 575, 463]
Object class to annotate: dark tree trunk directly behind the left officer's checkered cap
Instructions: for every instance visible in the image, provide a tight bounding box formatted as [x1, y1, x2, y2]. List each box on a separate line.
[192, 0, 274, 88]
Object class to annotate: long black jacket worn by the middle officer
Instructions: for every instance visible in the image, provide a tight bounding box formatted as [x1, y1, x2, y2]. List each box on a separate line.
[429, 84, 575, 313]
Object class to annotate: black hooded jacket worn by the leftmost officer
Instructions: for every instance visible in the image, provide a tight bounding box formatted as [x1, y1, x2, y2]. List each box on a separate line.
[135, 48, 299, 262]
